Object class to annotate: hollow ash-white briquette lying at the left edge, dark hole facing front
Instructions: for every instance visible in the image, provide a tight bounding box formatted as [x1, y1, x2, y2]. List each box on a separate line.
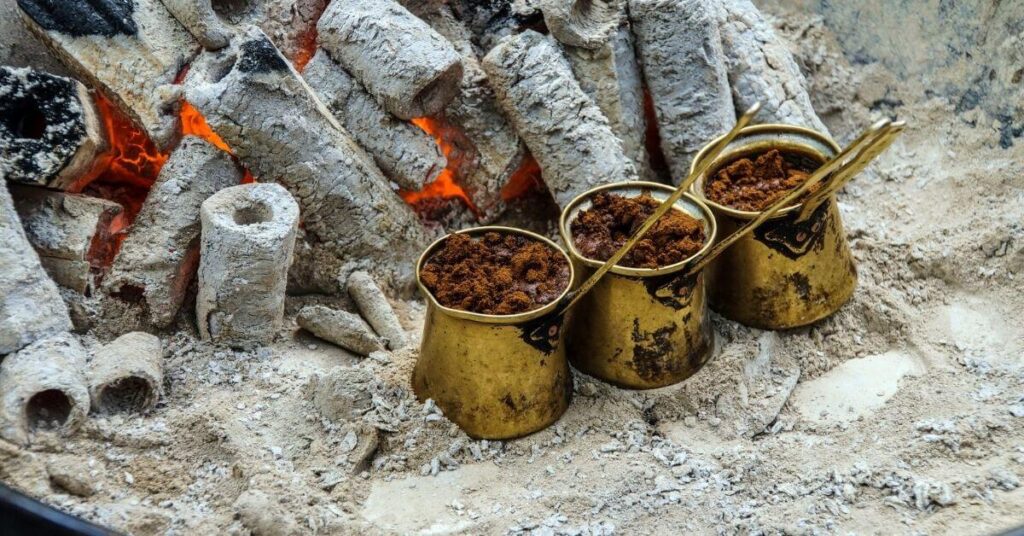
[0, 333, 89, 446]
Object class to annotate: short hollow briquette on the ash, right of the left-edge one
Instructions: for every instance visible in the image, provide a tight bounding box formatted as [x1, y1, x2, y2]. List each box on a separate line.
[88, 331, 164, 413]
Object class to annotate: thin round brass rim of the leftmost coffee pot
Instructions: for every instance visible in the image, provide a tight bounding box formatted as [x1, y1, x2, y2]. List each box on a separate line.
[416, 225, 575, 325]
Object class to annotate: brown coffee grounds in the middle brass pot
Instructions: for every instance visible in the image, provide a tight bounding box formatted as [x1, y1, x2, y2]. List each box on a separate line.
[571, 192, 705, 269]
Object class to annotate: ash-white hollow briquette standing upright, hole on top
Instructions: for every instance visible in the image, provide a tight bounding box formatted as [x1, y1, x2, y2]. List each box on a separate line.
[196, 183, 299, 347]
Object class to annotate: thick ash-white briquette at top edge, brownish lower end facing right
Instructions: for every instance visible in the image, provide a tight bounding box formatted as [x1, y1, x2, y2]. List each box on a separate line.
[317, 0, 463, 119]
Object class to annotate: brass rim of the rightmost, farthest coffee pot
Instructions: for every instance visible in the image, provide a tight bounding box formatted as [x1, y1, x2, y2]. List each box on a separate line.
[690, 123, 841, 219]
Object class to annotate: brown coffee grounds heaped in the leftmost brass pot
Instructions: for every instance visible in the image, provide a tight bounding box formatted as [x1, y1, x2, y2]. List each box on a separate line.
[421, 233, 569, 315]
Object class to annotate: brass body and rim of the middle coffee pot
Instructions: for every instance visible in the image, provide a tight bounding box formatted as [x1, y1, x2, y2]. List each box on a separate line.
[559, 181, 716, 389]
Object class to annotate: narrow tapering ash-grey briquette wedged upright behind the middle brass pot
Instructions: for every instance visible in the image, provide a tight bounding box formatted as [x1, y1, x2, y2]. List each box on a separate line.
[562, 25, 652, 178]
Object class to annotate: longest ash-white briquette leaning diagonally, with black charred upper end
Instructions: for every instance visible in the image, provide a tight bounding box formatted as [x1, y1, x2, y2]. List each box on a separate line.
[186, 30, 429, 289]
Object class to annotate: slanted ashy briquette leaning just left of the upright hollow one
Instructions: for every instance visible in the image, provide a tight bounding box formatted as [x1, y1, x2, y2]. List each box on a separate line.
[103, 136, 242, 328]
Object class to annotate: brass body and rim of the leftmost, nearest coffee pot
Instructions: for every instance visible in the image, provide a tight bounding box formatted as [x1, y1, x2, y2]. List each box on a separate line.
[413, 226, 575, 440]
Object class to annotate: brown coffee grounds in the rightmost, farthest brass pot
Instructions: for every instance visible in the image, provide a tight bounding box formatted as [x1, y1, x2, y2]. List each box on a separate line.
[705, 150, 821, 212]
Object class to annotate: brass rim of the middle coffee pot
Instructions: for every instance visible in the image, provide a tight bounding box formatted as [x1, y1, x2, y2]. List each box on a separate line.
[558, 180, 718, 278]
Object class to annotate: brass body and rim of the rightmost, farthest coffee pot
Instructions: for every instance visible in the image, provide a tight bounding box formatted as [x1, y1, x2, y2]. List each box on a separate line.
[692, 125, 857, 329]
